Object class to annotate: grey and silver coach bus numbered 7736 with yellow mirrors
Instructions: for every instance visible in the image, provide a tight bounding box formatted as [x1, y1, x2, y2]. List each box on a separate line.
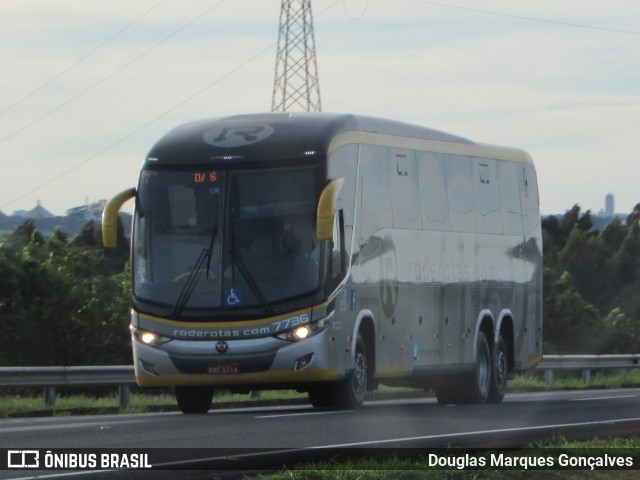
[102, 113, 542, 414]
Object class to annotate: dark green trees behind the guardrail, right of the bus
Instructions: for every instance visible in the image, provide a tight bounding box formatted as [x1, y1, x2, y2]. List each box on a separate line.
[542, 204, 640, 354]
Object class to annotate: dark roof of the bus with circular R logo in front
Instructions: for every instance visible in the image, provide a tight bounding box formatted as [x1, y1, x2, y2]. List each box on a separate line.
[146, 113, 528, 166]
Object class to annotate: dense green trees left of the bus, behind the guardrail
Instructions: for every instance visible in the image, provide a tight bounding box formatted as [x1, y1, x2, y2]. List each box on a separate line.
[0, 220, 131, 366]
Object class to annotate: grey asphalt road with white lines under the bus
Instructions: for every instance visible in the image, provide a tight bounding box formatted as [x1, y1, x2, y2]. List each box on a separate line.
[0, 389, 640, 478]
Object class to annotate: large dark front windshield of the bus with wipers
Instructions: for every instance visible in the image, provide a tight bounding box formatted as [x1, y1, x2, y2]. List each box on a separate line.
[133, 167, 321, 317]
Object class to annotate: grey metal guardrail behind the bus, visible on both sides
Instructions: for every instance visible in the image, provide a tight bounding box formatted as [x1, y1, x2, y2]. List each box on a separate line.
[0, 354, 640, 408]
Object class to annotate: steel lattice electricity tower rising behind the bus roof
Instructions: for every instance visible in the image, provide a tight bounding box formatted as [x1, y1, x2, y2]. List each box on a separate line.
[271, 0, 322, 112]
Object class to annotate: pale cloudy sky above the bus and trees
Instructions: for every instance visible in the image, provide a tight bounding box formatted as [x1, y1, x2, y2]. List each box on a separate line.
[0, 0, 640, 215]
